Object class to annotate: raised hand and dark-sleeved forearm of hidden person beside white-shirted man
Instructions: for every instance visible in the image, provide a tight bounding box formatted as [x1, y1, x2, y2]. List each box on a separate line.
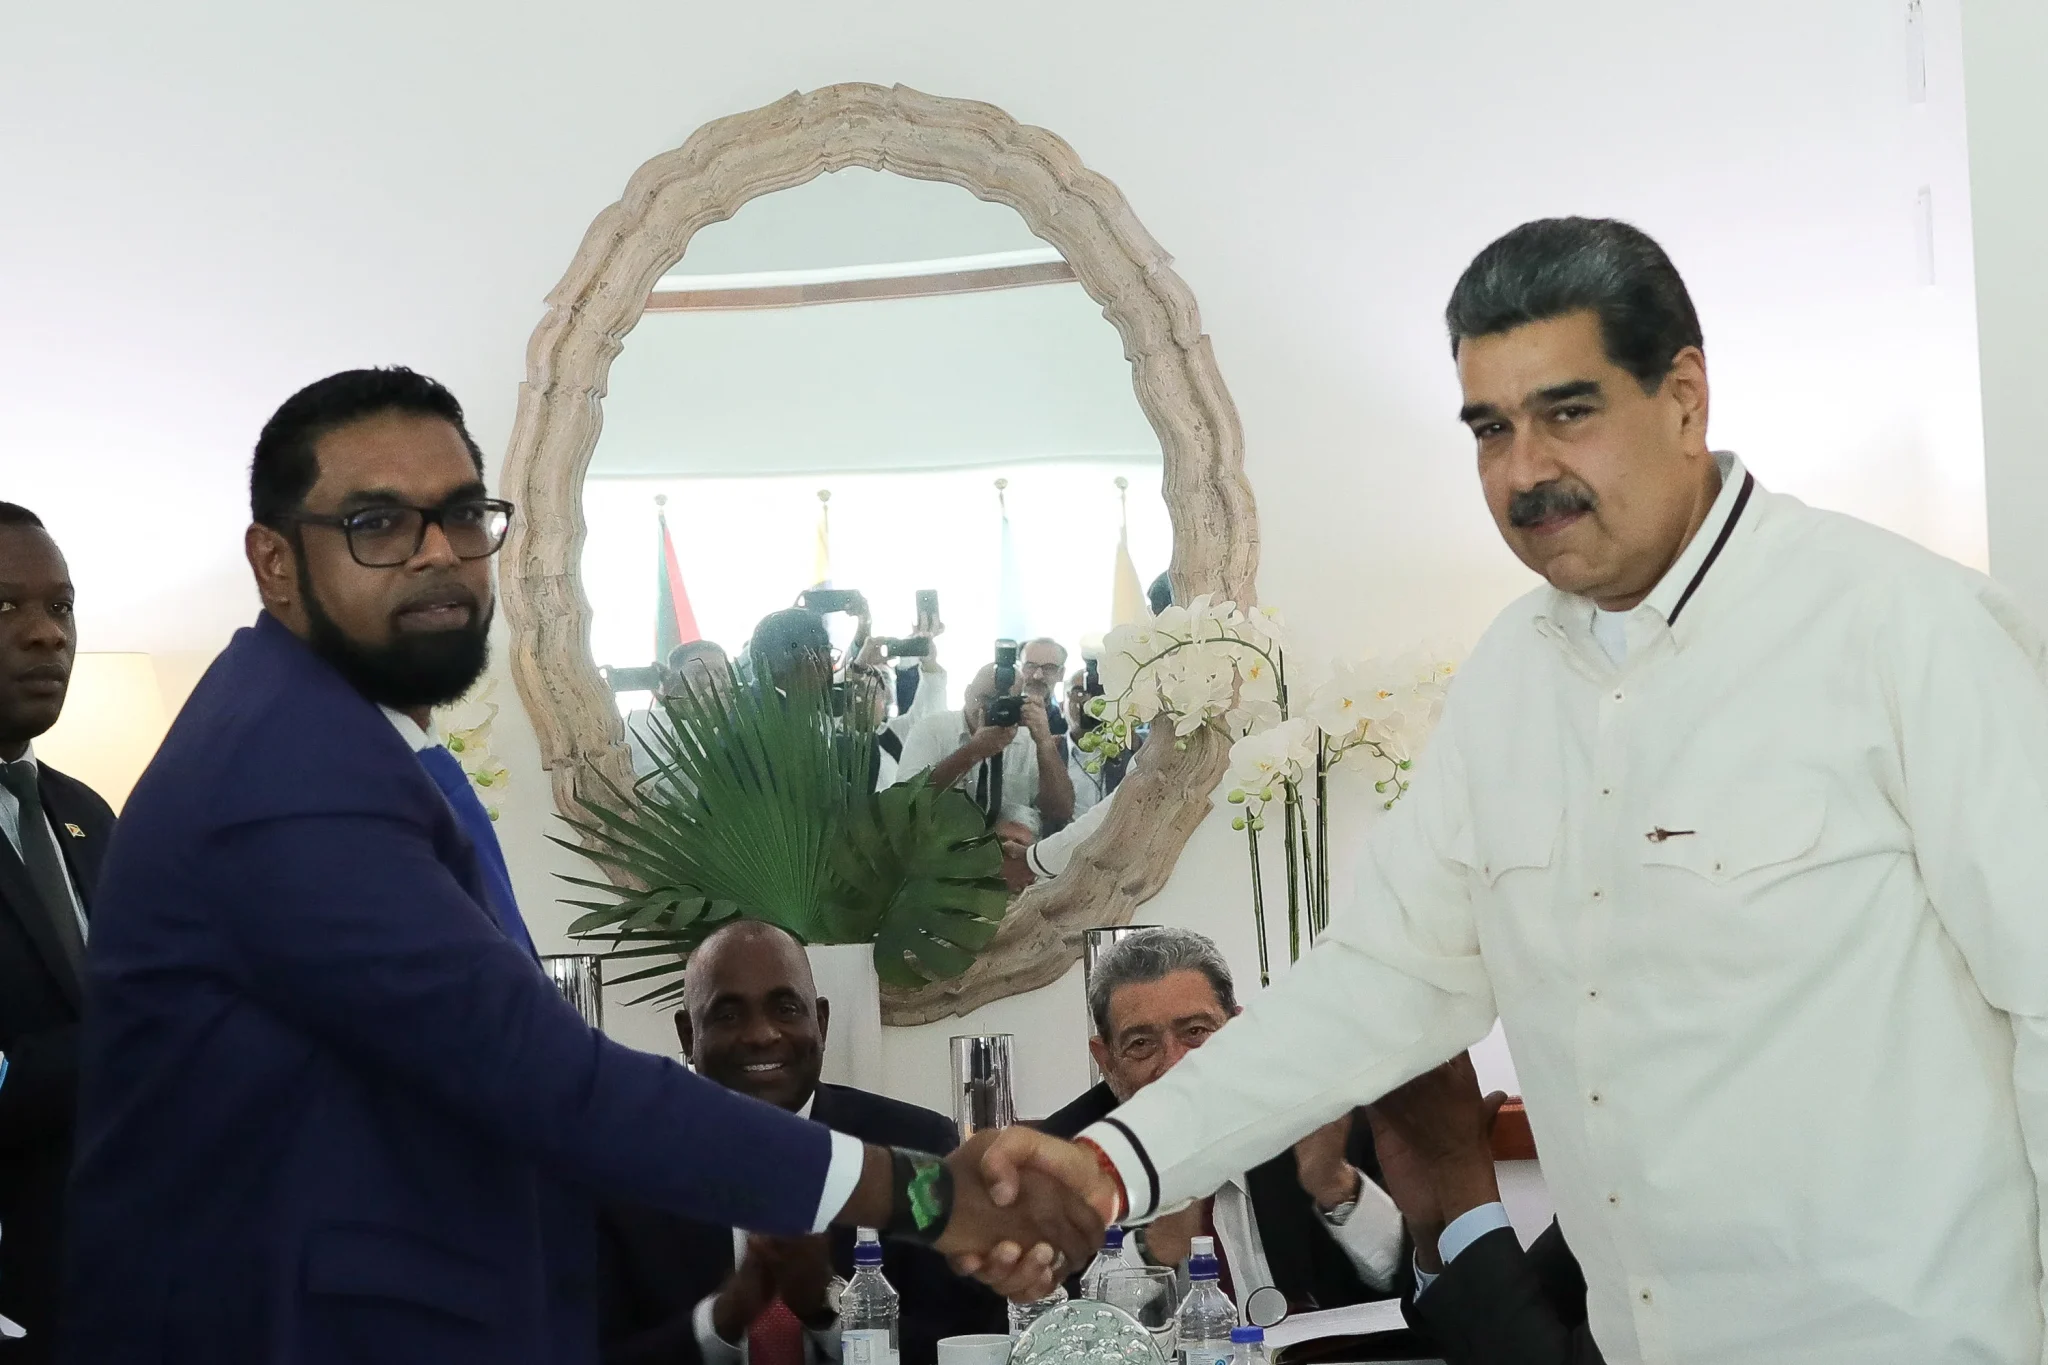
[1370, 1054, 1602, 1365]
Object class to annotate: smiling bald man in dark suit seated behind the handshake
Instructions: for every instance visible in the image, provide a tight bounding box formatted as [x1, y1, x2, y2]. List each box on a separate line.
[598, 921, 1006, 1365]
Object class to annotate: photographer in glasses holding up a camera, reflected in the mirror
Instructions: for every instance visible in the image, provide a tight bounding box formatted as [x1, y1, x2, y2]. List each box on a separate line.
[899, 641, 1073, 839]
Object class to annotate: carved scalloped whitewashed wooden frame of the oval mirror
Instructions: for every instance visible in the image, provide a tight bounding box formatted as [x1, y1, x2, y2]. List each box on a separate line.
[502, 84, 1257, 1023]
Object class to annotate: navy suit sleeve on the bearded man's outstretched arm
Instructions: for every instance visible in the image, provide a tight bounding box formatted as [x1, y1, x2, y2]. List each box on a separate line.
[217, 814, 831, 1234]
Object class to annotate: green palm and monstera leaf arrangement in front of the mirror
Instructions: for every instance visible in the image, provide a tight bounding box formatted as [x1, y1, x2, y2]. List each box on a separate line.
[555, 677, 1006, 1003]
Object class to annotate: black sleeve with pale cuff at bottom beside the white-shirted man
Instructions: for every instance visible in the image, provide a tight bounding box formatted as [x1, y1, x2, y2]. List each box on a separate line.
[1409, 1224, 1602, 1365]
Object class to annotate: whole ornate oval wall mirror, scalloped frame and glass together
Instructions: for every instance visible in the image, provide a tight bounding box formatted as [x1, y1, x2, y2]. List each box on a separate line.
[504, 84, 1257, 1023]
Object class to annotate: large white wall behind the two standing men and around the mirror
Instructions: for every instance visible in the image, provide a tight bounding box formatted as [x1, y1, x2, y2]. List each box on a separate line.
[0, 0, 1982, 1109]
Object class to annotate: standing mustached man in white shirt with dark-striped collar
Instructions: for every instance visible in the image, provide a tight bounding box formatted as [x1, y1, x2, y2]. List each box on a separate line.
[970, 219, 2048, 1365]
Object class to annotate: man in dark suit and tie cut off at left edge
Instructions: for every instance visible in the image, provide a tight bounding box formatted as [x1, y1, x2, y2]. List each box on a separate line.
[0, 501, 115, 1365]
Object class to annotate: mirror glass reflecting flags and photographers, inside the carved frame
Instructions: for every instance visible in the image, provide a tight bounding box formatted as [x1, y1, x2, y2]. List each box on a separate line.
[582, 168, 1171, 875]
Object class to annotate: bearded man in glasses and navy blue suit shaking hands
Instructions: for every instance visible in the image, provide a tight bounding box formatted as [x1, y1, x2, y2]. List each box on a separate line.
[66, 368, 1100, 1365]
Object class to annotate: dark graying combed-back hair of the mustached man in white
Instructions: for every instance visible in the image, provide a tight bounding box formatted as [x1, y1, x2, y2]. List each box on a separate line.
[1444, 219, 1706, 393]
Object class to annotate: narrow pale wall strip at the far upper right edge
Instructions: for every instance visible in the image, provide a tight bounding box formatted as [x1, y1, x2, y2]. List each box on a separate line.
[1962, 0, 2048, 620]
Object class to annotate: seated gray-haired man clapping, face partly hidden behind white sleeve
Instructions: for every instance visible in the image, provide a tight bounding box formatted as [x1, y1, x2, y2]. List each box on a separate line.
[1040, 927, 1409, 1314]
